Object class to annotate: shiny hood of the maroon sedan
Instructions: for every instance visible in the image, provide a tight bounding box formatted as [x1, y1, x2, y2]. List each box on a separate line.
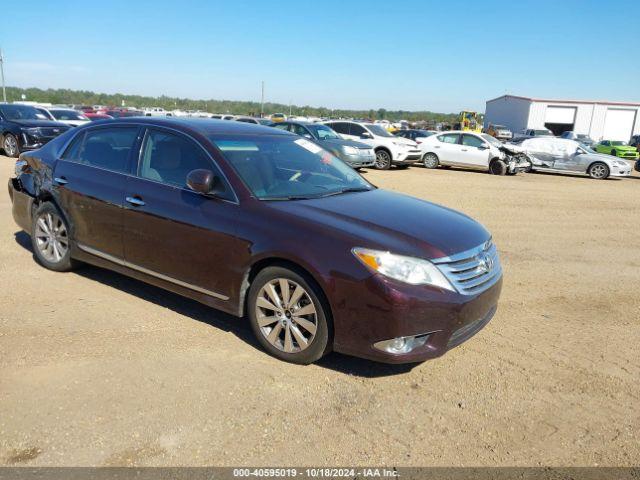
[269, 189, 490, 258]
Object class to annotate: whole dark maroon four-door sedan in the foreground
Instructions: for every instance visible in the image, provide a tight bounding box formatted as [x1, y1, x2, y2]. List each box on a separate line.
[9, 117, 502, 363]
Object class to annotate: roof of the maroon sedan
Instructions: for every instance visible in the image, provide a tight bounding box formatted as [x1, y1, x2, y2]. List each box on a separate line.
[79, 117, 289, 135]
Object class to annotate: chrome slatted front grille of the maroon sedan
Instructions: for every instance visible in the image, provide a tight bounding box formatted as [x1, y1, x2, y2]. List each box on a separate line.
[432, 240, 502, 295]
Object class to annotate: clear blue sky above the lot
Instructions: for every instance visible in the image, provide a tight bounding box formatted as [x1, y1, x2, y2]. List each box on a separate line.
[0, 0, 640, 112]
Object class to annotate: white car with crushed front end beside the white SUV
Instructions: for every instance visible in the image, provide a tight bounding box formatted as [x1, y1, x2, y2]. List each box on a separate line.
[420, 131, 531, 175]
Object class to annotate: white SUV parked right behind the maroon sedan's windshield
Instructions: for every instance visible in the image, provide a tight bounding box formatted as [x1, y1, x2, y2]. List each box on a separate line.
[324, 120, 422, 170]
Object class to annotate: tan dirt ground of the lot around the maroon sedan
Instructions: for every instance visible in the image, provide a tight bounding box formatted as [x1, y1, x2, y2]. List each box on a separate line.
[0, 157, 640, 466]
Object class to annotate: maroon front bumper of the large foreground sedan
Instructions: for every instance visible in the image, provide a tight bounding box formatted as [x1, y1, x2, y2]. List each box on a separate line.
[334, 275, 502, 363]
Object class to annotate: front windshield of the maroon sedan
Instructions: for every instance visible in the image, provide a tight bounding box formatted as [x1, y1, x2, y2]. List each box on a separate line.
[209, 135, 375, 200]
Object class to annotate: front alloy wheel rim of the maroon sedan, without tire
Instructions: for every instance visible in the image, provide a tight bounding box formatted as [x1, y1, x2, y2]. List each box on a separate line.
[256, 278, 318, 353]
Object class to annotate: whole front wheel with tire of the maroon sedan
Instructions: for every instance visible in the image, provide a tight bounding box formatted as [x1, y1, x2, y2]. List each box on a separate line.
[247, 266, 330, 365]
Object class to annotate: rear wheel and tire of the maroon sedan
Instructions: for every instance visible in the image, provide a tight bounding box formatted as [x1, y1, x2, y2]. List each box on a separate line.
[31, 202, 79, 272]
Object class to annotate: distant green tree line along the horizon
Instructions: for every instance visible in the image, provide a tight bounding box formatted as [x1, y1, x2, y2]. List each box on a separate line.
[1, 87, 457, 122]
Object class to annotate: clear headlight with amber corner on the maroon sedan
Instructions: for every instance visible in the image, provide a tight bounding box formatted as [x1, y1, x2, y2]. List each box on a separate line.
[352, 247, 455, 292]
